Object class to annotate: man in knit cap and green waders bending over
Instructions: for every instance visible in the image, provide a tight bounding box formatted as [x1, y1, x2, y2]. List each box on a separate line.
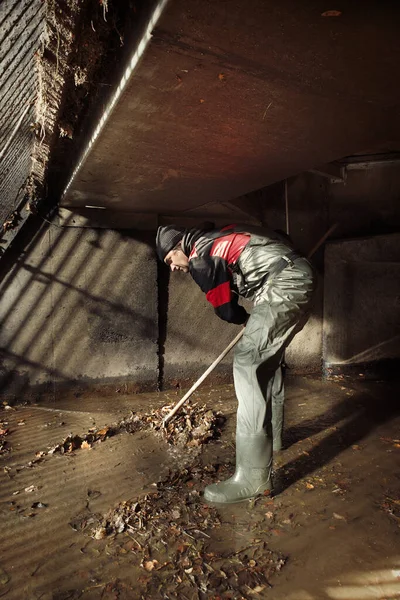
[156, 225, 315, 503]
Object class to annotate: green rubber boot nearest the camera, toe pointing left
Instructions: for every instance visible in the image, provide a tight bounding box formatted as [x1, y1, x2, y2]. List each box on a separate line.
[204, 433, 272, 504]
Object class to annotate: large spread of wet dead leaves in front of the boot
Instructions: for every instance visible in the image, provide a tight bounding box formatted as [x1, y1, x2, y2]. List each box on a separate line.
[86, 464, 285, 600]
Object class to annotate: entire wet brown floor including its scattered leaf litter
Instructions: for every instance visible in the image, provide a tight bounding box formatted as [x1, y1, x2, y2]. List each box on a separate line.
[0, 378, 400, 600]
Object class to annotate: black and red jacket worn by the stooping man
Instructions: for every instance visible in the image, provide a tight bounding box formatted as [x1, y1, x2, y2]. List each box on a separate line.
[182, 225, 250, 325]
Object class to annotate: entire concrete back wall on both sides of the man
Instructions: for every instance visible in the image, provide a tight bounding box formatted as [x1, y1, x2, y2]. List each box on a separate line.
[0, 167, 400, 395]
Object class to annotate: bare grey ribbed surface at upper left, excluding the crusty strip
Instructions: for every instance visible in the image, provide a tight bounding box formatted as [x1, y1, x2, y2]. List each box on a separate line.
[0, 0, 45, 223]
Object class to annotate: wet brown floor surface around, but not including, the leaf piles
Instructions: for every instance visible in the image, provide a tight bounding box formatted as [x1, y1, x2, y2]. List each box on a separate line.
[0, 377, 400, 600]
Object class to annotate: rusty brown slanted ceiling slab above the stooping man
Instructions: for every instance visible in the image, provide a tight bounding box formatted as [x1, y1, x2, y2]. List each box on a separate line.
[62, 0, 400, 214]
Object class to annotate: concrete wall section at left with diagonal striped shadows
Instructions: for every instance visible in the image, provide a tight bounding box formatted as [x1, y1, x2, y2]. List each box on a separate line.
[0, 220, 158, 396]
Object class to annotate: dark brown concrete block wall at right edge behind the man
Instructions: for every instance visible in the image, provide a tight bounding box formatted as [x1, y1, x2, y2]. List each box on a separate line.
[323, 234, 400, 377]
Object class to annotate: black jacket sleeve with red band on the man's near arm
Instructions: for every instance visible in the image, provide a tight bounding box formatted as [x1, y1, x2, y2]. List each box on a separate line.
[189, 257, 248, 325]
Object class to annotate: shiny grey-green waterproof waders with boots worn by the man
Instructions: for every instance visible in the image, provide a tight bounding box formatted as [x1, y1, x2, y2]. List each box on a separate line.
[205, 234, 315, 502]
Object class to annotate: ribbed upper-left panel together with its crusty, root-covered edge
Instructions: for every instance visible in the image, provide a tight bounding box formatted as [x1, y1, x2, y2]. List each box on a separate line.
[0, 0, 80, 248]
